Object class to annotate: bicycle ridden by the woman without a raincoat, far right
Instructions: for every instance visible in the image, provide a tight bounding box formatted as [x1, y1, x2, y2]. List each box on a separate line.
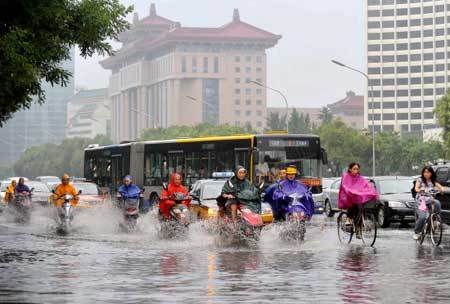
[417, 189, 443, 247]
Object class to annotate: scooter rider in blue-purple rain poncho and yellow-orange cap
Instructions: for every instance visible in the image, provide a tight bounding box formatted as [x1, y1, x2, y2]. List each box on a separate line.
[273, 166, 314, 220]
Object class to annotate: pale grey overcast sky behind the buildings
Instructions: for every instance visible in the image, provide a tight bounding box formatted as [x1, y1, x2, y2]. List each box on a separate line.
[75, 0, 364, 107]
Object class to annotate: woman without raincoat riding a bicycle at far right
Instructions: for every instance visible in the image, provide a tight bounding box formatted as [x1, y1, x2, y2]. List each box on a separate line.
[414, 166, 444, 240]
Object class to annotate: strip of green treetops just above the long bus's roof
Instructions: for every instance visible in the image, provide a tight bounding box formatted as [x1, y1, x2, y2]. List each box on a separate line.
[140, 123, 253, 140]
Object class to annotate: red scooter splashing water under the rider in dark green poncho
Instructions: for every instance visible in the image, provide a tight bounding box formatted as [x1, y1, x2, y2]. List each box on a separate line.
[219, 181, 264, 243]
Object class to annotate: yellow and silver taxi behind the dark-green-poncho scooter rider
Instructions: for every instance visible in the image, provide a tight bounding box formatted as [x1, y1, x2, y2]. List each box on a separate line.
[190, 179, 273, 224]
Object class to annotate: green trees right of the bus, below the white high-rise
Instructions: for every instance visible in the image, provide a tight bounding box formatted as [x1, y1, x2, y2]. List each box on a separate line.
[315, 119, 446, 176]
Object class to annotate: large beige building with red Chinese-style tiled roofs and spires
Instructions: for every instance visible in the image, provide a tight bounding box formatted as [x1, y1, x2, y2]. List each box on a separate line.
[101, 4, 281, 141]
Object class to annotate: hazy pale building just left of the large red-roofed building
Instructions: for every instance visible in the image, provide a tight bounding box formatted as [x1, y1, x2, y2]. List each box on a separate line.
[67, 89, 111, 138]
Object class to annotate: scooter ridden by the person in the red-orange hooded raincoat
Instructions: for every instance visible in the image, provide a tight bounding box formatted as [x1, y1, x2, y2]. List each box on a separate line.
[161, 192, 191, 238]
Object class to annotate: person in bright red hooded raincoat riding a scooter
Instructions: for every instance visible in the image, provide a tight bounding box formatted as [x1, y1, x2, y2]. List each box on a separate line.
[159, 173, 192, 220]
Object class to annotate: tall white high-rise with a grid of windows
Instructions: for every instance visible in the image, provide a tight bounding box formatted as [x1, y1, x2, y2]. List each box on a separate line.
[364, 0, 450, 132]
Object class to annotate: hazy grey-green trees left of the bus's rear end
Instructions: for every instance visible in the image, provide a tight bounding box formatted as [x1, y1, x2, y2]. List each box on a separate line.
[14, 135, 112, 178]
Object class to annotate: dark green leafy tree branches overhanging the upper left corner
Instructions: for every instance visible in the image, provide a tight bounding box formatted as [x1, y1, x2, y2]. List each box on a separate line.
[0, 0, 132, 127]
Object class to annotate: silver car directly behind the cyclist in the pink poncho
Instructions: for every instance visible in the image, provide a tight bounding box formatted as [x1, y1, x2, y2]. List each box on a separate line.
[371, 176, 415, 227]
